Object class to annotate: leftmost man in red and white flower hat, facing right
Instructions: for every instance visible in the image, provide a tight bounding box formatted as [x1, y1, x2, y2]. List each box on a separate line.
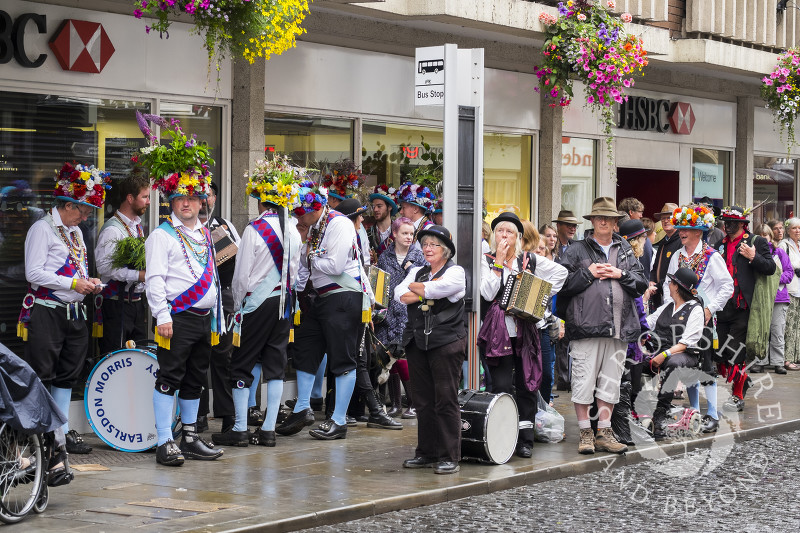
[17, 163, 110, 454]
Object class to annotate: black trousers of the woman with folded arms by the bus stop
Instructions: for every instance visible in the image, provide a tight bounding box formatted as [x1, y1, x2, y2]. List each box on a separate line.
[406, 337, 467, 462]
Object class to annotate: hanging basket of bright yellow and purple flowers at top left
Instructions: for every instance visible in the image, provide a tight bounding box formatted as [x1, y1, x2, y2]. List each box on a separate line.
[133, 0, 309, 66]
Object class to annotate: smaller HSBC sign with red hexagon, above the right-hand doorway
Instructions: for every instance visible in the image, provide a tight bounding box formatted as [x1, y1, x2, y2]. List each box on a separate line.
[617, 96, 695, 135]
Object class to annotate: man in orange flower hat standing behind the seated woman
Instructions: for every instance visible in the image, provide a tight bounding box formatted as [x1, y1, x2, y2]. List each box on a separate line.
[659, 205, 733, 433]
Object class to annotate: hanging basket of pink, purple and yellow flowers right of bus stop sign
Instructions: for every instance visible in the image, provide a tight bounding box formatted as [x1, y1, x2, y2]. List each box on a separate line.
[534, 0, 647, 165]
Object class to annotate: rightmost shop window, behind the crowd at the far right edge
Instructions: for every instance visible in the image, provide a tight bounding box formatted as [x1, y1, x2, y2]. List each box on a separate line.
[753, 156, 796, 228]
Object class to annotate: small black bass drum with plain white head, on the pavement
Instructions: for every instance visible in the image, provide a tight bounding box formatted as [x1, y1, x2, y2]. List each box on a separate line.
[458, 390, 519, 465]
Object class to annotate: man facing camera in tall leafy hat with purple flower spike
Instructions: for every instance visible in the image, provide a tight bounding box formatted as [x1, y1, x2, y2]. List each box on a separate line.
[137, 113, 224, 466]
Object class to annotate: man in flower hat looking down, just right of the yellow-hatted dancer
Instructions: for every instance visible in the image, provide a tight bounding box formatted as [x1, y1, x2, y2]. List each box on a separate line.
[276, 181, 371, 440]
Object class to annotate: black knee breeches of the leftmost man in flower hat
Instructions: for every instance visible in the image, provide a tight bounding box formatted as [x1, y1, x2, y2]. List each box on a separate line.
[23, 304, 89, 389]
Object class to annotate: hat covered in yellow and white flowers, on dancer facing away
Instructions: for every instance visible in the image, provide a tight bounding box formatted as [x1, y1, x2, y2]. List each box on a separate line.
[244, 154, 306, 209]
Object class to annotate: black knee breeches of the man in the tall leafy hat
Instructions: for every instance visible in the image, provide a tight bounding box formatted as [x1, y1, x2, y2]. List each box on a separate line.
[155, 311, 211, 400]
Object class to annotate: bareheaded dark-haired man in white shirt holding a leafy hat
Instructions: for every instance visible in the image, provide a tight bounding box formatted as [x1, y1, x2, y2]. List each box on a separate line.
[94, 174, 150, 354]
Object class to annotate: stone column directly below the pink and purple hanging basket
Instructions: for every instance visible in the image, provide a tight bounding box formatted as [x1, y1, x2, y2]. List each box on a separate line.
[536, 98, 564, 227]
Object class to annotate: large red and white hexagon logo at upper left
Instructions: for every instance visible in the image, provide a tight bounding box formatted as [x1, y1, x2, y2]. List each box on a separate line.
[50, 19, 114, 74]
